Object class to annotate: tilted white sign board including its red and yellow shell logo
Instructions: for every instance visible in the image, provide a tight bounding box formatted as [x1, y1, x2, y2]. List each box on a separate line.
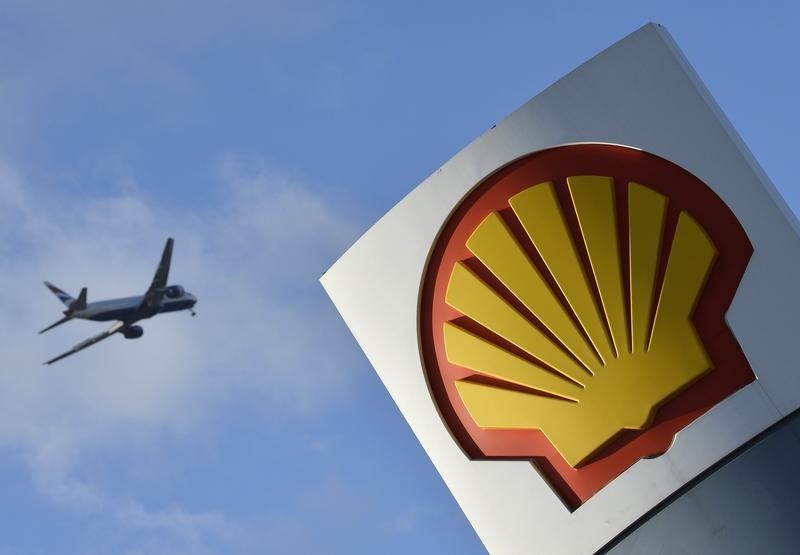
[322, 24, 800, 553]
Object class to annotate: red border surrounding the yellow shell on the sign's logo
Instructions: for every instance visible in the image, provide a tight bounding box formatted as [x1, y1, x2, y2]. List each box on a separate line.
[420, 144, 756, 510]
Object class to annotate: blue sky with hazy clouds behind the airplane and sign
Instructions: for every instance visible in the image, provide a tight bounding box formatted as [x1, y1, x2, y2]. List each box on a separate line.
[0, 0, 800, 555]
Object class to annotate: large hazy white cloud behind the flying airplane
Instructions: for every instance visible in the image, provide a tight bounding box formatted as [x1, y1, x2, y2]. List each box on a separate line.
[0, 156, 355, 553]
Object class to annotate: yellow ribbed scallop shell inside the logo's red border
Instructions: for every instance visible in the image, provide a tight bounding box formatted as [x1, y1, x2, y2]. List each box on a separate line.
[444, 176, 717, 467]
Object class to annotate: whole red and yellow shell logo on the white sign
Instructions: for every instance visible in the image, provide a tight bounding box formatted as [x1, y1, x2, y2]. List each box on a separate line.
[420, 144, 755, 510]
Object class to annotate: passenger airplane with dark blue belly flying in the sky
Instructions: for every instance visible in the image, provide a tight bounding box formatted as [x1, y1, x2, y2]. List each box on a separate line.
[39, 238, 197, 364]
